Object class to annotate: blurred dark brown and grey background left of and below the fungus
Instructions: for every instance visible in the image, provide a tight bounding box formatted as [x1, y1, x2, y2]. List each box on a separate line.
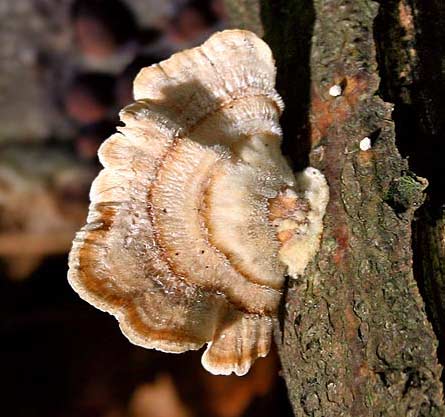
[0, 0, 292, 417]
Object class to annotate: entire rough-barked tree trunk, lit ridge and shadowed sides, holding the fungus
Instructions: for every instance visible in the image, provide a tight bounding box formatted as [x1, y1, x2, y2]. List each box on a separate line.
[228, 0, 445, 417]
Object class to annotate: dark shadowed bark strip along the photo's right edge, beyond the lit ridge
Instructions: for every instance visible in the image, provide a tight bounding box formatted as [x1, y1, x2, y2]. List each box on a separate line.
[375, 0, 445, 370]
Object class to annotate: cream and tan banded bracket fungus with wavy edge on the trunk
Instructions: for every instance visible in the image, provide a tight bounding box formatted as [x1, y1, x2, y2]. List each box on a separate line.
[68, 30, 328, 375]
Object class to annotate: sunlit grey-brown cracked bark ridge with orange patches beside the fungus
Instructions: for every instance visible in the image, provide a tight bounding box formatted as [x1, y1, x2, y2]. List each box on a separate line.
[262, 0, 444, 417]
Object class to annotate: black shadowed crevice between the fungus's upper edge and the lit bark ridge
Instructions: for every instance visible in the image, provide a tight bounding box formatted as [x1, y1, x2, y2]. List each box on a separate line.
[261, 0, 315, 171]
